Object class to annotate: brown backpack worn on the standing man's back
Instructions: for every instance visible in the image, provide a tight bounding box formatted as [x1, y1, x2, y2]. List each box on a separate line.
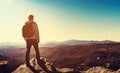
[22, 22, 34, 38]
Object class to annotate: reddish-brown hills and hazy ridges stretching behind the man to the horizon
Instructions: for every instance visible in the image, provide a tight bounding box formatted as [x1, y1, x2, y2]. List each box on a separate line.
[0, 40, 120, 73]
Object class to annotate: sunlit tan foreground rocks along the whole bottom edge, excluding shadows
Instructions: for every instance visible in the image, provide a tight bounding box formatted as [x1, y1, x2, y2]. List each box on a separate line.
[12, 59, 120, 73]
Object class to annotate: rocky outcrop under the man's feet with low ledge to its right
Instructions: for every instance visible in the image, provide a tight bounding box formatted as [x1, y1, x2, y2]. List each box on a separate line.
[12, 58, 79, 73]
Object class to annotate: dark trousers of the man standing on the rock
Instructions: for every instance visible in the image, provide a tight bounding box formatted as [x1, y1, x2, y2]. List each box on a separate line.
[26, 39, 40, 62]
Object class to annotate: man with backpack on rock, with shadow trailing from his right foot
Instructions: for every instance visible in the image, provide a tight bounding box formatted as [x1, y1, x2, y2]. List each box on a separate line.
[22, 15, 47, 71]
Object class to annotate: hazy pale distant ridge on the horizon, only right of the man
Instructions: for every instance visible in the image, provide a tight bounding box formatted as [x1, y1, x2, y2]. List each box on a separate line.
[44, 40, 120, 46]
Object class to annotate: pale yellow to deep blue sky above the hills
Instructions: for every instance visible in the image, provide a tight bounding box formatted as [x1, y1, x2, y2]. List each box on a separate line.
[0, 0, 120, 42]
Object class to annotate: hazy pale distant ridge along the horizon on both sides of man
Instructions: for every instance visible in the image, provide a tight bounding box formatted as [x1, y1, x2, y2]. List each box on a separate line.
[0, 39, 120, 48]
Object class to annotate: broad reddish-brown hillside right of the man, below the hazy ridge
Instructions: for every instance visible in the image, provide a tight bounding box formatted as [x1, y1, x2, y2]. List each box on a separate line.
[41, 43, 120, 70]
